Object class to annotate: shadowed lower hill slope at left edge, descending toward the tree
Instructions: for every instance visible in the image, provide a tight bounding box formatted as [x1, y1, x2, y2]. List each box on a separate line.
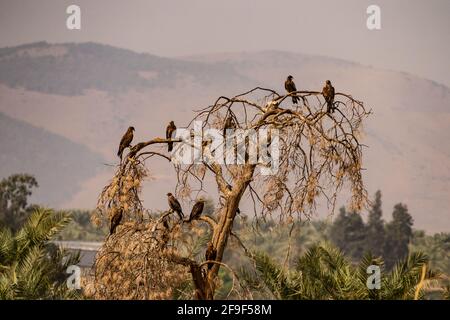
[0, 113, 102, 206]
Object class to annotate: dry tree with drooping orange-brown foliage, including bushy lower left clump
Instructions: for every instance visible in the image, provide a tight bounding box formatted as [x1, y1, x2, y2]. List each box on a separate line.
[89, 88, 370, 299]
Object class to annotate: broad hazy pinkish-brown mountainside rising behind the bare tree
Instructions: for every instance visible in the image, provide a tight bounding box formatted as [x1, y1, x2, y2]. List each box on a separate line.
[0, 42, 450, 232]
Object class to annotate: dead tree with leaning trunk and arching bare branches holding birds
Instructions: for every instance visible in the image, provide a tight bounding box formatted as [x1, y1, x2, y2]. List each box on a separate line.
[93, 87, 370, 299]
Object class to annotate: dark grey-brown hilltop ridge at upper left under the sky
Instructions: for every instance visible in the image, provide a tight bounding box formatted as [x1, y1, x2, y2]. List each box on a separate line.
[0, 42, 253, 96]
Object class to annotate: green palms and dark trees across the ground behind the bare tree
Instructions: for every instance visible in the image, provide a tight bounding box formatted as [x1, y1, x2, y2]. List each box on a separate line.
[0, 175, 450, 299]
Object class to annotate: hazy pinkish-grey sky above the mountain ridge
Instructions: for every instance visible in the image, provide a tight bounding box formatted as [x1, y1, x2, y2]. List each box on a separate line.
[0, 0, 450, 86]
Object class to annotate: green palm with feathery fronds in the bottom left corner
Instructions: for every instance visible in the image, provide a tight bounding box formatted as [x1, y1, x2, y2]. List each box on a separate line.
[0, 209, 79, 299]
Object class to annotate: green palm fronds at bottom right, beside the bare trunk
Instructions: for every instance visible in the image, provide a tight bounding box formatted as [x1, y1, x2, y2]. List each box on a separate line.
[242, 243, 439, 300]
